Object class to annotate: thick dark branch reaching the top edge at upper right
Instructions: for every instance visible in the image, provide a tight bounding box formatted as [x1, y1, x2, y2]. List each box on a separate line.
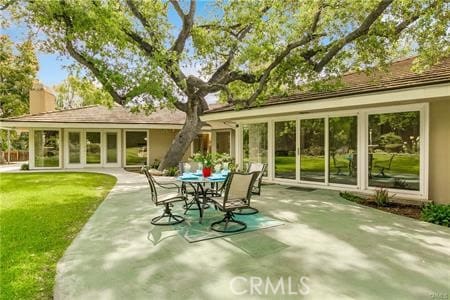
[314, 0, 393, 72]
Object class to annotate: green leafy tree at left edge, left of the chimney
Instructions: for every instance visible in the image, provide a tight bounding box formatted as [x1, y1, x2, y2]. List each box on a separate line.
[0, 35, 38, 118]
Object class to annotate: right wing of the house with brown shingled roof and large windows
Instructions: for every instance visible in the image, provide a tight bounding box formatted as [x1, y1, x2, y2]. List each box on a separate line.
[204, 58, 450, 203]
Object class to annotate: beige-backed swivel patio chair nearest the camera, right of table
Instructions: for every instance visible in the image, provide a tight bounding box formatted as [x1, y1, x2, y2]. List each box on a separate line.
[210, 172, 258, 233]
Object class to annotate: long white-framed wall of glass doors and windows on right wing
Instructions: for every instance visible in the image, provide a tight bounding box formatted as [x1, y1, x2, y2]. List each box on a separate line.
[240, 104, 428, 198]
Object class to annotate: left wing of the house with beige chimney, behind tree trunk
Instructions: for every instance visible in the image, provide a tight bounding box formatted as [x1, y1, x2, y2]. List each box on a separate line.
[0, 85, 235, 169]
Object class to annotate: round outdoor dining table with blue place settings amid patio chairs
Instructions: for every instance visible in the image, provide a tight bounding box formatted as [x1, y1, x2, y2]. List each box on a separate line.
[177, 173, 227, 223]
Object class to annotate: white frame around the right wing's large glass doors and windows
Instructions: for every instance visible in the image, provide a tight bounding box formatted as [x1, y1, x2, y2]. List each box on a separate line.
[235, 103, 429, 199]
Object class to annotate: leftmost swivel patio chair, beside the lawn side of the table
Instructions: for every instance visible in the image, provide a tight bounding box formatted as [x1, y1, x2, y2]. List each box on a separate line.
[142, 168, 187, 225]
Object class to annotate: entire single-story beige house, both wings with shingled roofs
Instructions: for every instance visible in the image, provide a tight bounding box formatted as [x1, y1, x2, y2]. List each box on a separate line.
[1, 58, 450, 203]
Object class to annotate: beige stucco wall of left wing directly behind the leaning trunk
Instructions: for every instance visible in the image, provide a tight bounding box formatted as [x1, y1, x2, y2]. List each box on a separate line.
[149, 129, 191, 164]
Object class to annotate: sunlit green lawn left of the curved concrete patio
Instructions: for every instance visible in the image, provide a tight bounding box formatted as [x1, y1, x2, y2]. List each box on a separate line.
[0, 173, 116, 299]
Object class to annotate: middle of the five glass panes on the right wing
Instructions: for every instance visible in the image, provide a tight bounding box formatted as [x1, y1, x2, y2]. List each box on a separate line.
[300, 118, 325, 182]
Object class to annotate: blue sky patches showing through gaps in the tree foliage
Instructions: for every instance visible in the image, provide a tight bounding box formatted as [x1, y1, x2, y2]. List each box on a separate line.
[0, 0, 213, 90]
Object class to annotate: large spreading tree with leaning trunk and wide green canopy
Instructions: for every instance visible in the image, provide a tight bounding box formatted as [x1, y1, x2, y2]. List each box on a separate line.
[8, 0, 449, 169]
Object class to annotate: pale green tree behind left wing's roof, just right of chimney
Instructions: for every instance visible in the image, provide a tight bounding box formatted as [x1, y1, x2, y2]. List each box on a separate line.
[54, 76, 114, 109]
